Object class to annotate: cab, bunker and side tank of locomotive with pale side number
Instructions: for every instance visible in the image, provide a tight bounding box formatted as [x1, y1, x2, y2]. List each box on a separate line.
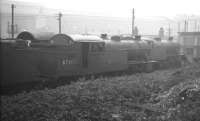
[35, 34, 127, 78]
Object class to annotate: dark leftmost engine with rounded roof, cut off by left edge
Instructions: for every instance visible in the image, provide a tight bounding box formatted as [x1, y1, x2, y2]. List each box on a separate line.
[0, 31, 60, 85]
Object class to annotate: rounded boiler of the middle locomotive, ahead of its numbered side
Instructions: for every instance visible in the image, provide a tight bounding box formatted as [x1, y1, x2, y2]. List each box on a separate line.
[105, 37, 153, 61]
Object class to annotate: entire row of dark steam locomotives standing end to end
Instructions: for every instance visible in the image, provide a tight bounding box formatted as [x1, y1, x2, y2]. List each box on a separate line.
[1, 32, 180, 85]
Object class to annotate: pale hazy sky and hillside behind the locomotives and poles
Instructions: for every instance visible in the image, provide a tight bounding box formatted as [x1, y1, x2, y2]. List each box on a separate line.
[0, 0, 200, 38]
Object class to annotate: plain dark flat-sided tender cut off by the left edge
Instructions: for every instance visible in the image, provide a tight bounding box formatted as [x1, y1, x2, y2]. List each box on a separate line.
[0, 39, 39, 86]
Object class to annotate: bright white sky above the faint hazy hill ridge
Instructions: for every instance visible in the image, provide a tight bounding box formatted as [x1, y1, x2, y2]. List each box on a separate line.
[10, 0, 200, 17]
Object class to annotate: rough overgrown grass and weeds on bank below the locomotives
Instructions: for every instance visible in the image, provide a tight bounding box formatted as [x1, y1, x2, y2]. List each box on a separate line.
[1, 65, 200, 121]
